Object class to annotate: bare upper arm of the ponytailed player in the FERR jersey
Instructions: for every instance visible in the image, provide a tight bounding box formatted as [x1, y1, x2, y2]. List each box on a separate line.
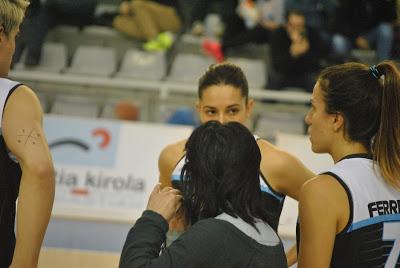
[298, 175, 349, 268]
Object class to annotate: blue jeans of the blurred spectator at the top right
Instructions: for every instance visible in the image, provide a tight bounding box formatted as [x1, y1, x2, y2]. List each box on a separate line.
[332, 23, 393, 61]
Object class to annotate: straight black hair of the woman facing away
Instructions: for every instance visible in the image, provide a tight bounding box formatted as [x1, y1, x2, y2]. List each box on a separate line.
[181, 121, 269, 226]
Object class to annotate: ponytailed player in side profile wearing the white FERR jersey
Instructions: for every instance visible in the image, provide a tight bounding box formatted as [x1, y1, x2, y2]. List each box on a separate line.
[298, 61, 400, 268]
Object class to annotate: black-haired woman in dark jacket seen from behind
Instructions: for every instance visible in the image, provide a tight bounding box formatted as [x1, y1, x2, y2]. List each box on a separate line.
[120, 121, 287, 267]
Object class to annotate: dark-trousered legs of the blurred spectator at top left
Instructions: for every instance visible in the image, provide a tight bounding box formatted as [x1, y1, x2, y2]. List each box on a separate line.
[14, 0, 99, 67]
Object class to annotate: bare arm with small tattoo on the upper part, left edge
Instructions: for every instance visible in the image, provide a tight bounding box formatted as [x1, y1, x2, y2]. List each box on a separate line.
[2, 86, 55, 267]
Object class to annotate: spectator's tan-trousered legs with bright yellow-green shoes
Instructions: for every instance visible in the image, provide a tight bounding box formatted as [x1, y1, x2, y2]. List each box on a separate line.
[112, 0, 182, 51]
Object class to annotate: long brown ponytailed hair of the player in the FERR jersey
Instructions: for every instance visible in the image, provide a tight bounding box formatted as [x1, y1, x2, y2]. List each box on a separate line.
[318, 61, 400, 189]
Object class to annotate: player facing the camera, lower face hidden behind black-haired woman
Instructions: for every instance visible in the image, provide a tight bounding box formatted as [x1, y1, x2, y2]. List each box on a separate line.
[159, 62, 314, 260]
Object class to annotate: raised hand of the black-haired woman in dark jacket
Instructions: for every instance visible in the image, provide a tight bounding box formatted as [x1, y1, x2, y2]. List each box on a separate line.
[147, 184, 182, 221]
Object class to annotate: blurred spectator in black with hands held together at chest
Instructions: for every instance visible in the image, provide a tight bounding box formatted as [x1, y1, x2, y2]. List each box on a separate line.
[267, 10, 328, 91]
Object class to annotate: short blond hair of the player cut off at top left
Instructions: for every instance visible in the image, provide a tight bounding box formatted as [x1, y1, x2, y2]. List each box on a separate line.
[0, 0, 29, 36]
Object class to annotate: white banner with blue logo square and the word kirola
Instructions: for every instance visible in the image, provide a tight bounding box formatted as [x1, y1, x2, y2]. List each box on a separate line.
[44, 116, 192, 222]
